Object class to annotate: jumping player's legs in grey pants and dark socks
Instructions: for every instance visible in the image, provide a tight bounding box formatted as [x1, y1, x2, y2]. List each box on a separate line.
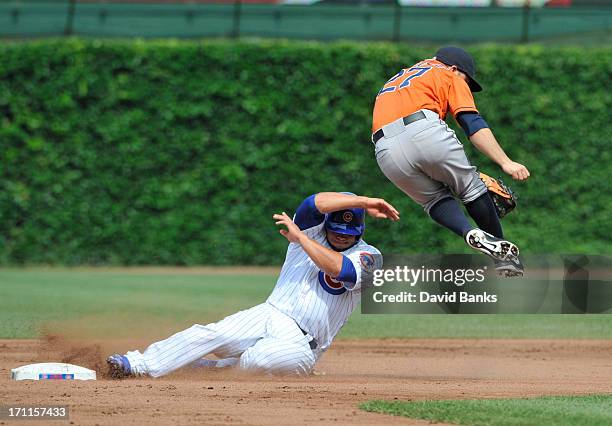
[376, 113, 518, 260]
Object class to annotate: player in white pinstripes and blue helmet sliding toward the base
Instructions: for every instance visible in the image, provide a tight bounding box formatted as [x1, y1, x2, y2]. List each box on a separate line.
[107, 192, 399, 378]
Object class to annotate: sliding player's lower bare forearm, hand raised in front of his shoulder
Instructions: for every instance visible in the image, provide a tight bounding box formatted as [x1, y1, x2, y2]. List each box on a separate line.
[272, 212, 343, 278]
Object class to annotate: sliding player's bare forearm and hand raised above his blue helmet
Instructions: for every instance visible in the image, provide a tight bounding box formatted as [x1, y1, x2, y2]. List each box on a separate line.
[315, 192, 399, 221]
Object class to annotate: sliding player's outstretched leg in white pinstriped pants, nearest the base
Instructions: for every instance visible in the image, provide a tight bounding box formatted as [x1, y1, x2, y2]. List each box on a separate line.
[125, 303, 270, 377]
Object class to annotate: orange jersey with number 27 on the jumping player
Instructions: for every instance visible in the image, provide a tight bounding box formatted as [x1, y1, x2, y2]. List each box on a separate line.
[372, 59, 478, 133]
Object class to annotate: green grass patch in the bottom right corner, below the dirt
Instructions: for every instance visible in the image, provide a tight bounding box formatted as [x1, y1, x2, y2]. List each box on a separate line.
[360, 395, 612, 426]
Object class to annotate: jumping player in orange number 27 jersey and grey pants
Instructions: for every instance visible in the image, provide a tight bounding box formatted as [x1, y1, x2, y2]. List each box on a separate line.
[372, 47, 529, 276]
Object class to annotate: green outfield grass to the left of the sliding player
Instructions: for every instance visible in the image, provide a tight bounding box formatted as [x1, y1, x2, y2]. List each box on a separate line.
[0, 269, 274, 338]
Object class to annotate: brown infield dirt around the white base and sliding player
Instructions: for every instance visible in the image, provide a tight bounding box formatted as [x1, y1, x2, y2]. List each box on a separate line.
[0, 337, 612, 425]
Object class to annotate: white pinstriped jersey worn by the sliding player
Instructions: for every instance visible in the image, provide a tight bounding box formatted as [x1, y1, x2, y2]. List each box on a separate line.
[267, 222, 382, 351]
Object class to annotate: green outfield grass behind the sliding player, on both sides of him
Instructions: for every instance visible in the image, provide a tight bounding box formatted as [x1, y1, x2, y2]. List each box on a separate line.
[0, 268, 612, 339]
